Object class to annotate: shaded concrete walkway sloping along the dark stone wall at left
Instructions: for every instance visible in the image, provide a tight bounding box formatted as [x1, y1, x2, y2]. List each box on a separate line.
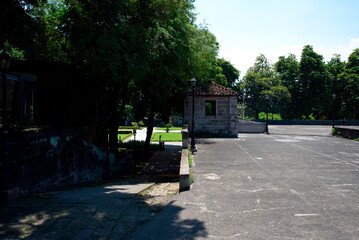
[0, 179, 154, 240]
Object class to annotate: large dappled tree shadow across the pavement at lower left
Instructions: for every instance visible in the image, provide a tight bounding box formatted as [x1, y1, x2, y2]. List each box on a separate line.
[0, 179, 207, 240]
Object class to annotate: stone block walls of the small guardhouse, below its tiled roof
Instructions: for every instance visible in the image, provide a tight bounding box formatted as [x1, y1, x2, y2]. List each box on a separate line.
[184, 96, 238, 136]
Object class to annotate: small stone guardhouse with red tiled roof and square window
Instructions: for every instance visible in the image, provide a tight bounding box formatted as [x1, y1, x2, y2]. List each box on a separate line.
[184, 81, 238, 137]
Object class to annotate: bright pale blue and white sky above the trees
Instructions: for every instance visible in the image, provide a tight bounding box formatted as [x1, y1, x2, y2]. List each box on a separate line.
[194, 0, 359, 78]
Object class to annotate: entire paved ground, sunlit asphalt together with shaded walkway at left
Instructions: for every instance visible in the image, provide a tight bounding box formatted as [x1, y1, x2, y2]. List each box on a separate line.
[0, 126, 359, 240]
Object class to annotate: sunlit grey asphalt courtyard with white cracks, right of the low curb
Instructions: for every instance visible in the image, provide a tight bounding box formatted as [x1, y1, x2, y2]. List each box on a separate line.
[126, 126, 359, 240]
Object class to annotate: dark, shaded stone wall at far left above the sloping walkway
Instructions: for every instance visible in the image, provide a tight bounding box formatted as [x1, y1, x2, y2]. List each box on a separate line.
[1, 129, 109, 201]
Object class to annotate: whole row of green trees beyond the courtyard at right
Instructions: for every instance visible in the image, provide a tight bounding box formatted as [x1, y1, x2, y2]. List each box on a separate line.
[239, 45, 359, 119]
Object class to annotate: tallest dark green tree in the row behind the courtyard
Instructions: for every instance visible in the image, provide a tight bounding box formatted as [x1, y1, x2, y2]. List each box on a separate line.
[298, 45, 331, 119]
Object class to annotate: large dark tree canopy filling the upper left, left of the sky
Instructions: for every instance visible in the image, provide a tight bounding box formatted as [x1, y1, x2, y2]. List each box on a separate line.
[1, 0, 228, 151]
